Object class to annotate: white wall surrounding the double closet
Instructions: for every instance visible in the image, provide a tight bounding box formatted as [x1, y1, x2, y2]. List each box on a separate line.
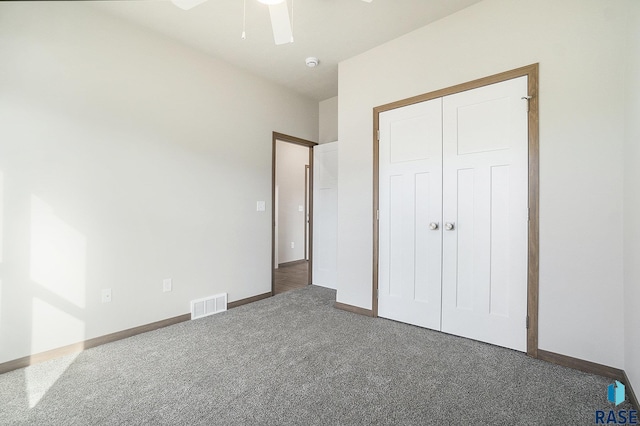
[337, 0, 628, 368]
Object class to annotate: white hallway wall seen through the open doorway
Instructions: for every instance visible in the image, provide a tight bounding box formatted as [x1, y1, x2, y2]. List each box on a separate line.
[276, 141, 309, 264]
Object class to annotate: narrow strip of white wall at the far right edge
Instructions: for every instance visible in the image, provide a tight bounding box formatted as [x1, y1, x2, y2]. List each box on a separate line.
[624, 0, 640, 395]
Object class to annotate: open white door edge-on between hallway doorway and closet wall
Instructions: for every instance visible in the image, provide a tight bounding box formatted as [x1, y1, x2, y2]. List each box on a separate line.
[312, 142, 338, 289]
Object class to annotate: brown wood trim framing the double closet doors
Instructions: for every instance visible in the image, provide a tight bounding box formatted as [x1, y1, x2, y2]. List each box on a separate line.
[371, 63, 540, 358]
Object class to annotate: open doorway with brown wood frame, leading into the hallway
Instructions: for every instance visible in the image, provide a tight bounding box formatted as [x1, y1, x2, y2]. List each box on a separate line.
[271, 132, 317, 295]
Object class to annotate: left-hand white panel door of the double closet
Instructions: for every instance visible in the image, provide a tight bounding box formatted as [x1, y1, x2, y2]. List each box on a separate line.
[378, 98, 442, 330]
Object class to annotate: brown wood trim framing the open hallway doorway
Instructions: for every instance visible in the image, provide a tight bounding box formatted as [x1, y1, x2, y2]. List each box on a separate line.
[271, 132, 318, 296]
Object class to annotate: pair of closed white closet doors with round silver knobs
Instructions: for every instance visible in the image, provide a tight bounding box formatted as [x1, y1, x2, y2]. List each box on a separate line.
[378, 76, 528, 351]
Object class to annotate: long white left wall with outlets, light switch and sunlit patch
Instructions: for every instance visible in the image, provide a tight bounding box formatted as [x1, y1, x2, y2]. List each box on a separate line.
[0, 2, 318, 363]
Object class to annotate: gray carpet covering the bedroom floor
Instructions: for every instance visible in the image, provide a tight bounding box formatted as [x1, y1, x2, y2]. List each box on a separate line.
[0, 286, 631, 425]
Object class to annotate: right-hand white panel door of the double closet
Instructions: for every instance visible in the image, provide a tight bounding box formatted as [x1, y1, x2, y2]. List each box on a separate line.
[442, 77, 528, 351]
